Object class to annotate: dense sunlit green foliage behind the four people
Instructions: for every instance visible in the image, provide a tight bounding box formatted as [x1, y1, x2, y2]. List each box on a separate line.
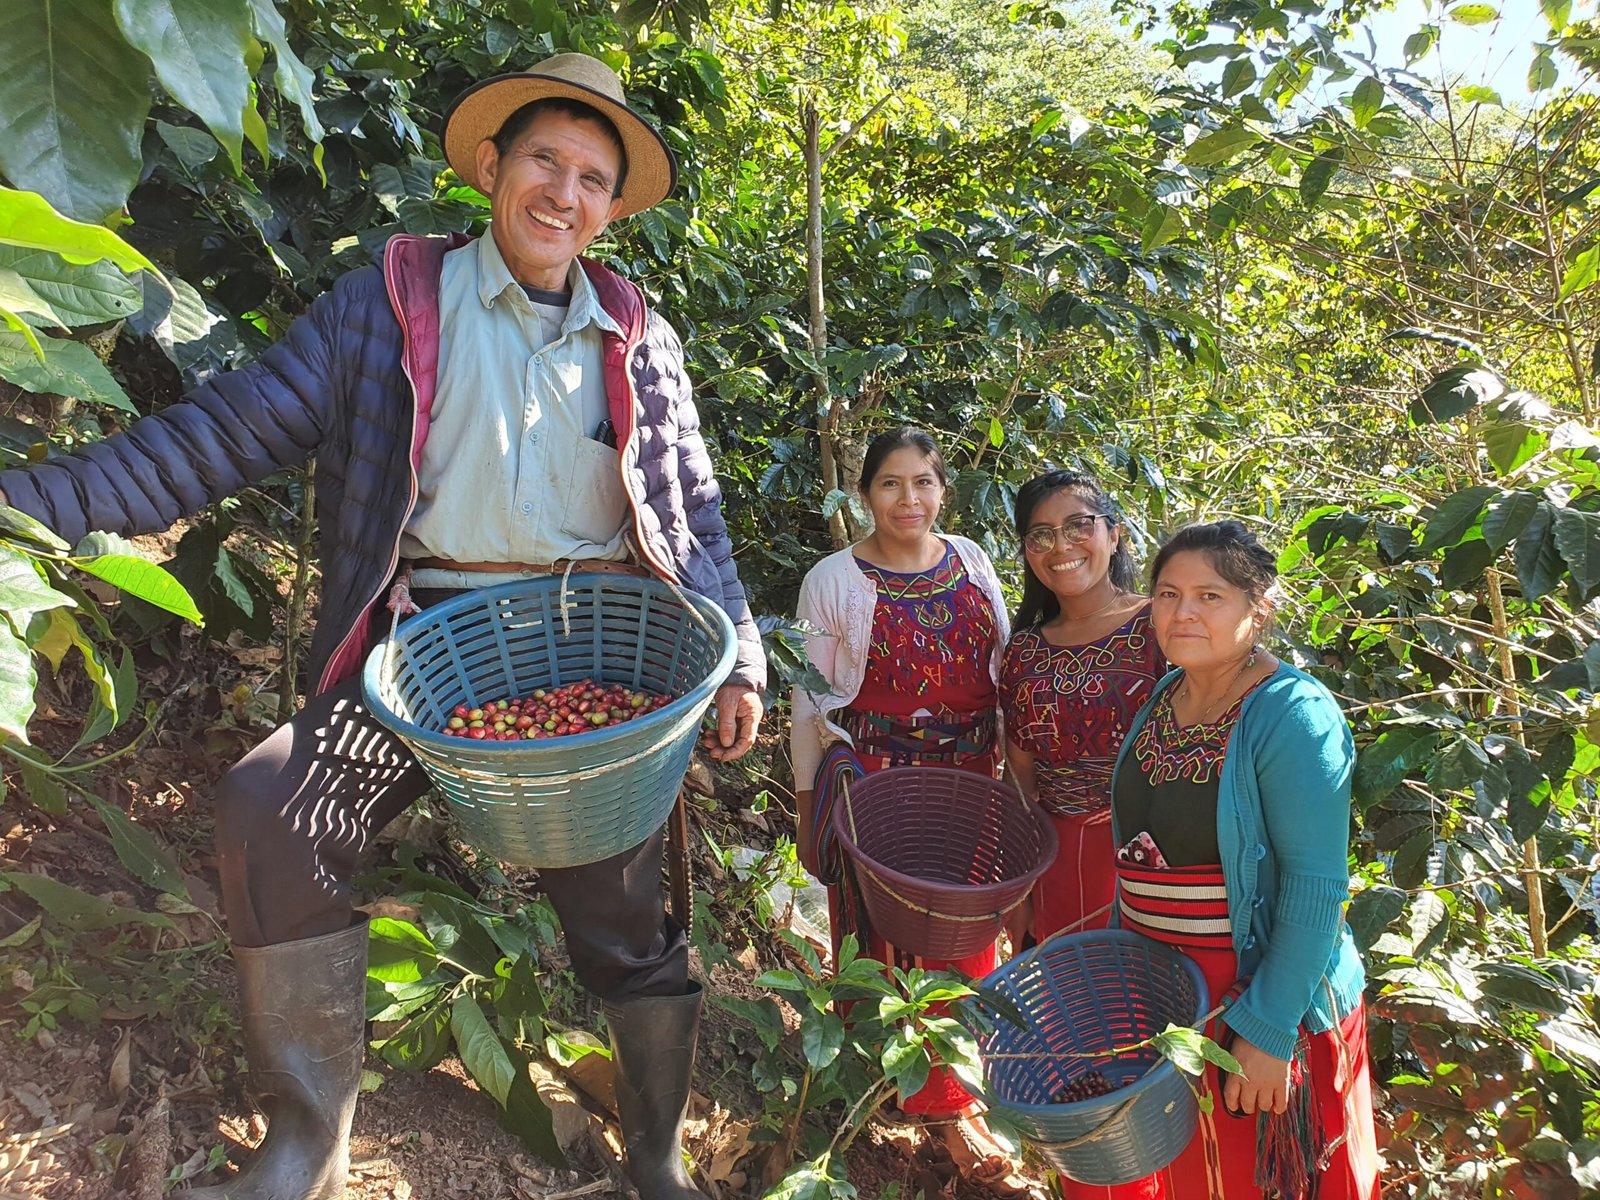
[0, 0, 1600, 1195]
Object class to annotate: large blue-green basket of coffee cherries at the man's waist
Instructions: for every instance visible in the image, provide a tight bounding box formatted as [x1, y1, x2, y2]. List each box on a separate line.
[362, 574, 734, 867]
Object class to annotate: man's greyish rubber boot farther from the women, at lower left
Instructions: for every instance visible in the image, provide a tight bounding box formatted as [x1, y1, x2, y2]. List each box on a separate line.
[179, 920, 366, 1200]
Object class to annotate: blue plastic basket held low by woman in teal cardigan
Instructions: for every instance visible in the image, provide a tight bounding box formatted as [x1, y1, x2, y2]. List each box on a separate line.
[978, 930, 1210, 1186]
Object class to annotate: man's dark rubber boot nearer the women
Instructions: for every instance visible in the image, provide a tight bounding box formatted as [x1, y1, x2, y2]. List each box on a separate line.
[605, 981, 707, 1200]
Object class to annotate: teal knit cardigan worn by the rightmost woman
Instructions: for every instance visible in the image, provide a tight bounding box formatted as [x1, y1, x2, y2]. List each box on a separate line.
[1112, 662, 1365, 1059]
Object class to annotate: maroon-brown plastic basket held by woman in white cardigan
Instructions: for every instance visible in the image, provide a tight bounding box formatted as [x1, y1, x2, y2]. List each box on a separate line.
[834, 766, 1056, 958]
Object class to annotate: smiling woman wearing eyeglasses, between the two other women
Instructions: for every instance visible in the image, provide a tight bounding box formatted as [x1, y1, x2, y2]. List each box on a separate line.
[1000, 470, 1166, 966]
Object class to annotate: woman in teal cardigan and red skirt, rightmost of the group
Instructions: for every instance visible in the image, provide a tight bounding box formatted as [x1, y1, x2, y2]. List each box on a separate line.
[1112, 522, 1378, 1200]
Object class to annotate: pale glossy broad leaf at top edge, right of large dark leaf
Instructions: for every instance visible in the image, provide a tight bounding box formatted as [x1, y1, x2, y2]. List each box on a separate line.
[114, 0, 251, 171]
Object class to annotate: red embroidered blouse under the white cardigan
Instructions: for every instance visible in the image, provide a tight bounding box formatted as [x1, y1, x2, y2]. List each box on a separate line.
[856, 546, 998, 717]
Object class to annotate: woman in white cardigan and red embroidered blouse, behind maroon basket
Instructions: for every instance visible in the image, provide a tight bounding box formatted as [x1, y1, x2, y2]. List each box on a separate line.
[790, 429, 1017, 1189]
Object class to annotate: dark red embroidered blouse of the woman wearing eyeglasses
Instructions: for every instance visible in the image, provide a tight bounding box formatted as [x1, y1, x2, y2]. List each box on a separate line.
[1000, 608, 1166, 816]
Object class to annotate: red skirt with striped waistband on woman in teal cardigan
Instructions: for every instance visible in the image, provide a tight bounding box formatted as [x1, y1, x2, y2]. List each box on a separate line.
[1061, 862, 1379, 1200]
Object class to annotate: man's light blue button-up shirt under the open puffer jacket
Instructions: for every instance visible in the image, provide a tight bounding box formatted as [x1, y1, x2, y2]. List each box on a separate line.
[400, 234, 627, 587]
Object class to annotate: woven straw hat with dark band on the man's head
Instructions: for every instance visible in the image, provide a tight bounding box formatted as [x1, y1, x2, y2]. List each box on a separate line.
[445, 54, 678, 216]
